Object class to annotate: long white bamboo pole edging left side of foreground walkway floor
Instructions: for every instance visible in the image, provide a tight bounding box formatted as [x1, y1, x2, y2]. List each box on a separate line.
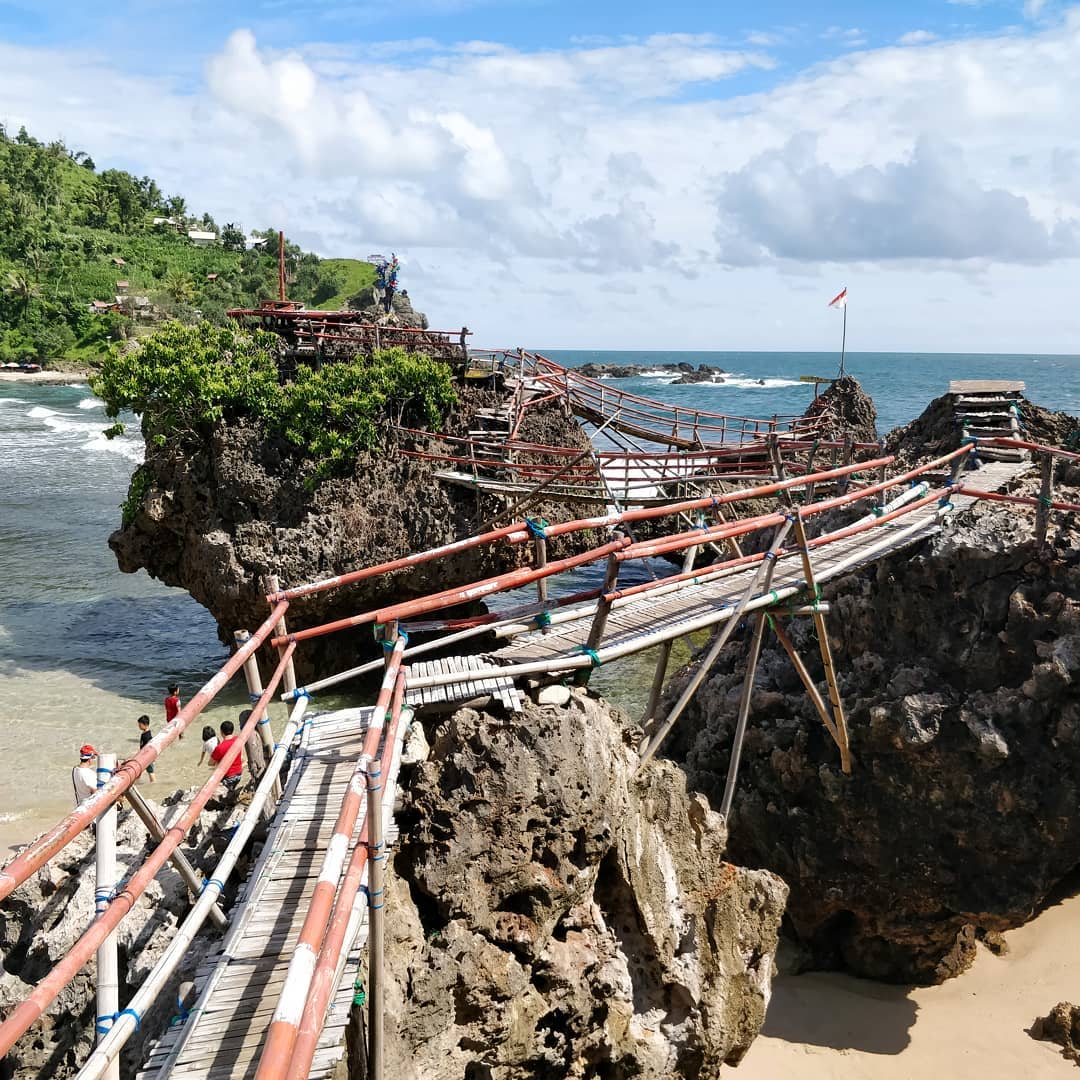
[77, 698, 308, 1080]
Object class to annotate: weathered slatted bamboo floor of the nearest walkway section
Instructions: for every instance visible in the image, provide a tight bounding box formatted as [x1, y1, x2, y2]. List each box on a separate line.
[137, 708, 404, 1080]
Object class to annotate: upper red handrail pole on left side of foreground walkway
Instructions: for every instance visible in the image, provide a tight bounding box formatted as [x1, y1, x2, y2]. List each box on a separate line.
[0, 600, 288, 900]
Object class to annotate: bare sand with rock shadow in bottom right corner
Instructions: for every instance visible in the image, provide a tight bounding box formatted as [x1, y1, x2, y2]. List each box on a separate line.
[732, 895, 1080, 1080]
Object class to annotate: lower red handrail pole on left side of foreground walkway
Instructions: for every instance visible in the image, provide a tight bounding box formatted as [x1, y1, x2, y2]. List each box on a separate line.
[0, 645, 296, 1057]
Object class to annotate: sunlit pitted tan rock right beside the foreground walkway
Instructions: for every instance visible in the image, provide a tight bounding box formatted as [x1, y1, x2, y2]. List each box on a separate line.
[387, 690, 786, 1080]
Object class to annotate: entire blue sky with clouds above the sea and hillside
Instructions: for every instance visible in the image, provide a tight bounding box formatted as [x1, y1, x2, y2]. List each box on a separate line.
[0, 0, 1080, 353]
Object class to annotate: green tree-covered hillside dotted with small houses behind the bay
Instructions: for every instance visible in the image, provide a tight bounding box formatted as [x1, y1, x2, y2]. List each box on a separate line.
[0, 125, 375, 363]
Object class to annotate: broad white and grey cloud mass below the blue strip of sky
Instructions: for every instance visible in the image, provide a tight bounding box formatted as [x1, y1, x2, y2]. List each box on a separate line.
[0, 15, 1080, 349]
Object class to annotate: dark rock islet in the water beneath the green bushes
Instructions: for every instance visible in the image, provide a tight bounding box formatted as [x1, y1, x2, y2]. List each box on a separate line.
[109, 389, 589, 678]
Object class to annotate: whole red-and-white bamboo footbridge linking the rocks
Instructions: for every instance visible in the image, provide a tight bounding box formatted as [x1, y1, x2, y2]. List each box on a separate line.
[0, 373, 1080, 1080]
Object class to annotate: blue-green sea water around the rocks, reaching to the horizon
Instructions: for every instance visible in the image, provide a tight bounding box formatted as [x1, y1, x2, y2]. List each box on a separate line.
[0, 350, 1080, 859]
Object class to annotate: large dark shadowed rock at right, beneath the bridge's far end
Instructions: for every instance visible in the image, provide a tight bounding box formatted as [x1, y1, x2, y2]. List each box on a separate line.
[672, 451, 1080, 982]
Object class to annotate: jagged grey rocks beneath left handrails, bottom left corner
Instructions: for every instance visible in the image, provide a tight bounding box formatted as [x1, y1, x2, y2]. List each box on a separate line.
[0, 789, 243, 1080]
